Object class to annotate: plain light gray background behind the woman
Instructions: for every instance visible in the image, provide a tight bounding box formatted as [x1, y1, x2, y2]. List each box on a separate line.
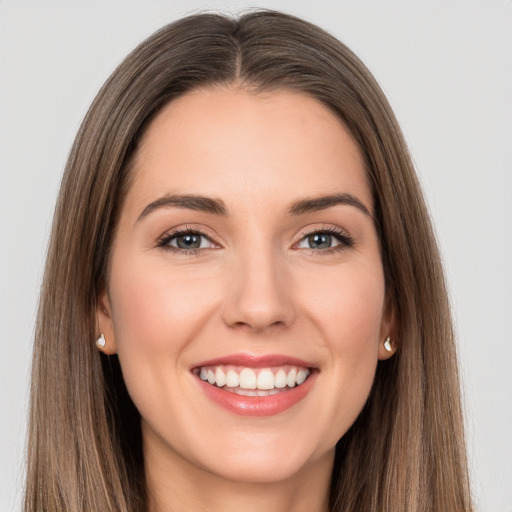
[0, 0, 512, 512]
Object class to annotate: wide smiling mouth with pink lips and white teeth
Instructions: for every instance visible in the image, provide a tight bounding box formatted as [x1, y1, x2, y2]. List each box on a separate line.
[191, 355, 318, 416]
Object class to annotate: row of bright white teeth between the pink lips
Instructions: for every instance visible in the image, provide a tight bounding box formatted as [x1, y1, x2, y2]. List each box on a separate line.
[198, 365, 310, 396]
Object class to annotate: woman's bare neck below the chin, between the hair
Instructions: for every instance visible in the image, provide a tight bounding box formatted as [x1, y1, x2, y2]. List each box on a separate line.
[145, 440, 334, 512]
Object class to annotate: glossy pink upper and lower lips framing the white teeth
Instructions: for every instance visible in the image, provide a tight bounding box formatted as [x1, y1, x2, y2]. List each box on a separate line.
[194, 354, 318, 416]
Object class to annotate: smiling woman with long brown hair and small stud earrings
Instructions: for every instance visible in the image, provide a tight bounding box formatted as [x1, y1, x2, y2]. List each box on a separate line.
[25, 11, 471, 511]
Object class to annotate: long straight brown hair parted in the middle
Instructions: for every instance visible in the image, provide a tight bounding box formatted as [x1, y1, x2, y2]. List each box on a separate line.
[25, 11, 472, 512]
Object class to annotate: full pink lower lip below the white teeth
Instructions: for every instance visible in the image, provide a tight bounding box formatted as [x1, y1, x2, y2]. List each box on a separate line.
[197, 372, 318, 416]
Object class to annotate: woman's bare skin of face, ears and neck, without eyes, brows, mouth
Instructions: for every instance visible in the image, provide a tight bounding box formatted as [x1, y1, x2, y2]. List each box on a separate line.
[98, 86, 393, 512]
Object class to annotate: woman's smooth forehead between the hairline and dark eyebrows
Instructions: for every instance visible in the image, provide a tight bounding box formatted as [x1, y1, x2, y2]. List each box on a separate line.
[129, 87, 372, 216]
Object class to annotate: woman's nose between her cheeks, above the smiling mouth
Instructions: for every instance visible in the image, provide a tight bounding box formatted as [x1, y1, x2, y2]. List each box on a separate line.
[222, 247, 296, 332]
